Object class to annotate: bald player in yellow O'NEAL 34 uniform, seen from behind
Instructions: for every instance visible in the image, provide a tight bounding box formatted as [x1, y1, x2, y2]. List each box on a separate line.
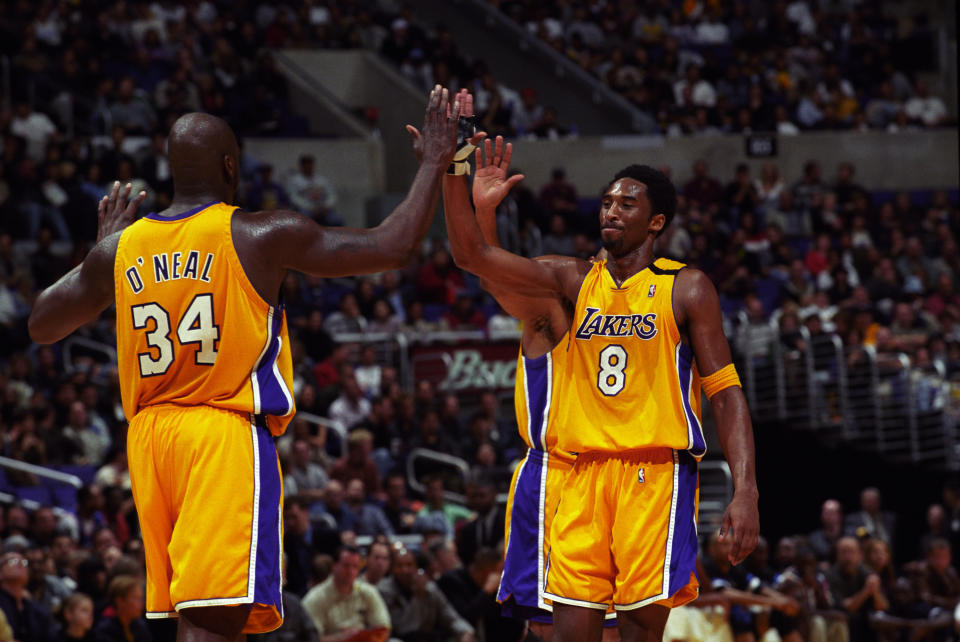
[30, 86, 464, 641]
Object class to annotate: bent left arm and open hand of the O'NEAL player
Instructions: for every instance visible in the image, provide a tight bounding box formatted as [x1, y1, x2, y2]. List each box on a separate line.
[28, 181, 147, 343]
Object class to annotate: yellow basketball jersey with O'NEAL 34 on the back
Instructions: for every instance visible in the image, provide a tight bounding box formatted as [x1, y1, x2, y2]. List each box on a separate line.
[114, 203, 294, 435]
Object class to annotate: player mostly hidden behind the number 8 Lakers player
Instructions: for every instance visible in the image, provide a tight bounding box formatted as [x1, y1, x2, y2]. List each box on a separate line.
[454, 136, 616, 642]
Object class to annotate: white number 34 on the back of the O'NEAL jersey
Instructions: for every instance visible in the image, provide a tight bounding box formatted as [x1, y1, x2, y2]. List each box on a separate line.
[130, 294, 220, 377]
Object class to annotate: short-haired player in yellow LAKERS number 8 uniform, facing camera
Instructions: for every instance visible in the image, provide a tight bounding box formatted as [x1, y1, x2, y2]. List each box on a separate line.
[443, 148, 759, 642]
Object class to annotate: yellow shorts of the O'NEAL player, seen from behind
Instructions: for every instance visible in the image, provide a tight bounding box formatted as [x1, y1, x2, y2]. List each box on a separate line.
[127, 405, 283, 633]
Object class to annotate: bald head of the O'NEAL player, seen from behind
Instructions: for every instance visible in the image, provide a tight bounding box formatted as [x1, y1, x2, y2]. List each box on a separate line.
[167, 112, 240, 203]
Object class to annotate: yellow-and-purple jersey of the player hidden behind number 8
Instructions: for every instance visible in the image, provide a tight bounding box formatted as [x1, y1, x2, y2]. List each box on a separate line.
[513, 337, 572, 459]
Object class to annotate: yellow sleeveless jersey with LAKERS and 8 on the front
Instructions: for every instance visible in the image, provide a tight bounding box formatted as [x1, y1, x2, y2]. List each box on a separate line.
[555, 259, 706, 458]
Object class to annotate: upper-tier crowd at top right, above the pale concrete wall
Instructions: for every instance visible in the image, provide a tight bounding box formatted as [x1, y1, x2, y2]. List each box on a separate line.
[495, 0, 949, 135]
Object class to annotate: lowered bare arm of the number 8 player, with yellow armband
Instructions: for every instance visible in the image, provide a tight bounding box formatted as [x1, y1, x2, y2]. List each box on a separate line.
[673, 268, 760, 564]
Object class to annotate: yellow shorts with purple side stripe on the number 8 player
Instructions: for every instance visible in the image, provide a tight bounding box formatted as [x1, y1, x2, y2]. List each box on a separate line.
[545, 448, 699, 611]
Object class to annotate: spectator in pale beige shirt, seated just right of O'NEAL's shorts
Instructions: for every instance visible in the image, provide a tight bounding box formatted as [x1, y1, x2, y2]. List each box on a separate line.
[303, 546, 390, 642]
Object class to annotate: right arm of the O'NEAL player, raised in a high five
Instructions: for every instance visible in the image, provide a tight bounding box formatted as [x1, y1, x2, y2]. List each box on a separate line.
[260, 85, 460, 277]
